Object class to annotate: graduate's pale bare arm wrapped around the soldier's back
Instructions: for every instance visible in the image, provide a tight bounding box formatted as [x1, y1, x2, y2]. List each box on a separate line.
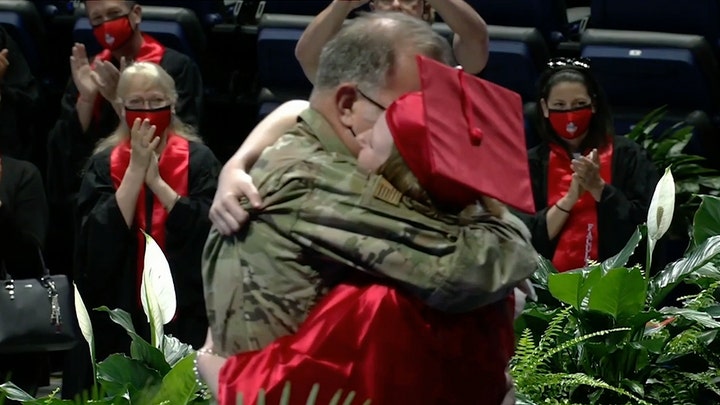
[210, 100, 308, 235]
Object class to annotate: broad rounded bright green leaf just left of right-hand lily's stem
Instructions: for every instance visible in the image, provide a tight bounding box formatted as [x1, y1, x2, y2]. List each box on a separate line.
[588, 268, 647, 320]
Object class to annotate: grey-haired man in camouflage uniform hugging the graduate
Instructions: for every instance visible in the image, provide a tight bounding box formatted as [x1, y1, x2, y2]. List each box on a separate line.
[203, 15, 536, 356]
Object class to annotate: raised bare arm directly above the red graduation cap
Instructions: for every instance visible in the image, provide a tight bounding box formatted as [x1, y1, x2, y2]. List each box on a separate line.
[427, 0, 489, 74]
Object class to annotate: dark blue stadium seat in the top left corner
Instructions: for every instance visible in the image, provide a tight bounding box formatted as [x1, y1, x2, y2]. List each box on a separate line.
[0, 0, 45, 77]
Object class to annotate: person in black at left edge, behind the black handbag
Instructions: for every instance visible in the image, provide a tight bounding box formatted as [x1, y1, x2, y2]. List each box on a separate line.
[0, 155, 48, 393]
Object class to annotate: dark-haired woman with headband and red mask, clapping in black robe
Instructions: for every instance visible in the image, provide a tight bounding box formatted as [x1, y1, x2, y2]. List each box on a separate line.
[522, 58, 658, 271]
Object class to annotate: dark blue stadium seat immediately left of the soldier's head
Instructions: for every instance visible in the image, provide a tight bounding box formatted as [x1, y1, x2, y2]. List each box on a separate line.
[257, 14, 313, 119]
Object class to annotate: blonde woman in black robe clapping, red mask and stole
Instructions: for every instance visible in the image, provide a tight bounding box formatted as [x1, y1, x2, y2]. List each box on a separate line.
[67, 62, 220, 396]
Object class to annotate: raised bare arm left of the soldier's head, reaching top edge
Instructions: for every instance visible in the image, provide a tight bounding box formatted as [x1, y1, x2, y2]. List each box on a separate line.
[295, 0, 370, 84]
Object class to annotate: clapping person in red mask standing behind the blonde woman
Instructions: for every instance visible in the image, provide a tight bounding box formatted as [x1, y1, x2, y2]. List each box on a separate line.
[47, 0, 202, 276]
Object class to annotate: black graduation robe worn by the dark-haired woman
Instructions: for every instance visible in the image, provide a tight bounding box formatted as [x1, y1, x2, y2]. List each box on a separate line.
[519, 136, 659, 261]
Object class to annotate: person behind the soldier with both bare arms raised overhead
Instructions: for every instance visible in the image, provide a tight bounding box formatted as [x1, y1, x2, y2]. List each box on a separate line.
[295, 0, 489, 79]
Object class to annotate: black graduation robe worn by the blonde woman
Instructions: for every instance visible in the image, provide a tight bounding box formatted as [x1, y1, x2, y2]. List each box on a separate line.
[75, 142, 221, 359]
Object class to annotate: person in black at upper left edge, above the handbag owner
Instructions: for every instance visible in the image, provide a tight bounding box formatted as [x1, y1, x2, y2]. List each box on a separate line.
[0, 25, 44, 161]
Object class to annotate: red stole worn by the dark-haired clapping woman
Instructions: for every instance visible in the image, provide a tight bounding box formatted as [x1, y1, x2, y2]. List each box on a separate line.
[547, 138, 613, 272]
